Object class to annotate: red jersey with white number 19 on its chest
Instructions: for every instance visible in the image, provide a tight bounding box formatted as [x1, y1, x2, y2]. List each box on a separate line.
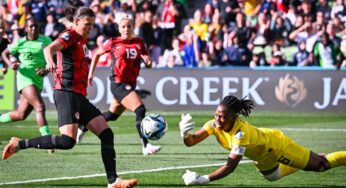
[103, 37, 148, 87]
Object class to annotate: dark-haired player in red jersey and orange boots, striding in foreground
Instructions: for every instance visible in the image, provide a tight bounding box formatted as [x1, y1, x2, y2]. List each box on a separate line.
[2, 6, 137, 188]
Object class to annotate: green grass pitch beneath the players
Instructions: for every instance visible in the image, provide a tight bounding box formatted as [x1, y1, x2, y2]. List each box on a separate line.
[0, 112, 346, 187]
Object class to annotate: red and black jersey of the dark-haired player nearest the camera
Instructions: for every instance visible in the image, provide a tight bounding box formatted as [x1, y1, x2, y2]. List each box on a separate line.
[54, 29, 91, 96]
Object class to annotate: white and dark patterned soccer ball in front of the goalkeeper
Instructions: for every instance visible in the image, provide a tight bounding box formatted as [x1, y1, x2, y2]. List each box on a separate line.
[141, 113, 168, 140]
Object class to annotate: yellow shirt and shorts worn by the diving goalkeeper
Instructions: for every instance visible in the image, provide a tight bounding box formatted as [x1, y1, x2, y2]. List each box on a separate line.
[203, 117, 306, 166]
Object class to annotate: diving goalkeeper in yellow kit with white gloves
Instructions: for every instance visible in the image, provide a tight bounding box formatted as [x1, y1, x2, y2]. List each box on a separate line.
[179, 96, 346, 185]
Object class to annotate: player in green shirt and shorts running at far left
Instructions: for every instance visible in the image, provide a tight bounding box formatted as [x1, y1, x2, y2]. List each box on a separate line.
[0, 18, 54, 153]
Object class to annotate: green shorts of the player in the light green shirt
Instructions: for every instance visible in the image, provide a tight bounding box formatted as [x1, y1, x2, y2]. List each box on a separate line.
[16, 69, 43, 93]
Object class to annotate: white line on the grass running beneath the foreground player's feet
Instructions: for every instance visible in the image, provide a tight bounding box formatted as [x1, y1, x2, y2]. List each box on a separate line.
[0, 160, 252, 186]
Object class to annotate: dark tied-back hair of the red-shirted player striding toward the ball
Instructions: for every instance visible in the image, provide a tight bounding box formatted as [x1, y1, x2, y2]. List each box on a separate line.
[64, 5, 96, 22]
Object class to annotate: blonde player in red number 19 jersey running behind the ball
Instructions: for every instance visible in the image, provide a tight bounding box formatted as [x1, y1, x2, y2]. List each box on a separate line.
[88, 16, 160, 156]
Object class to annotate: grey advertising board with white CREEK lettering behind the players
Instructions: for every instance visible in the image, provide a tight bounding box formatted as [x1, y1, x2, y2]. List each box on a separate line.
[3, 67, 346, 112]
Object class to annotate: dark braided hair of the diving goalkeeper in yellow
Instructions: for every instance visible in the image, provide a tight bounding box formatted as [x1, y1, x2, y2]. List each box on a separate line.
[220, 95, 255, 117]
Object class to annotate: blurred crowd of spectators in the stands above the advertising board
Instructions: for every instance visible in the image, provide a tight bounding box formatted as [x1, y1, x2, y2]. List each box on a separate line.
[0, 0, 346, 69]
